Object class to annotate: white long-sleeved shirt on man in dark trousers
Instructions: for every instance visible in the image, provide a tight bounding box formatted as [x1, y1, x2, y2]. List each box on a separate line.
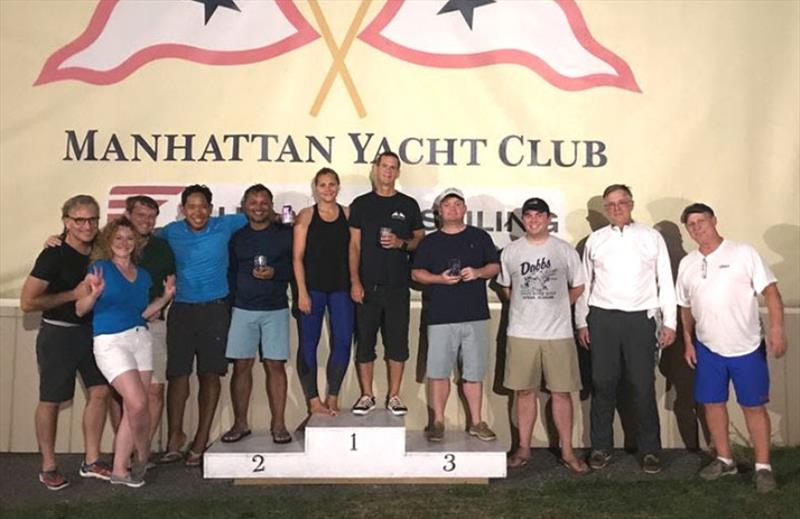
[575, 222, 678, 330]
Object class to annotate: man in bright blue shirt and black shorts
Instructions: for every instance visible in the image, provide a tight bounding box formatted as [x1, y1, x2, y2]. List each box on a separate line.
[155, 184, 247, 466]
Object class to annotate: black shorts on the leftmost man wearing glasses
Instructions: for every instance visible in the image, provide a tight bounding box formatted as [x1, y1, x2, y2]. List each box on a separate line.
[36, 322, 108, 403]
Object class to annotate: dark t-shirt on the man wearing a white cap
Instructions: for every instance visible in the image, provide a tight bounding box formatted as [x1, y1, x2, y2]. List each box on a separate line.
[414, 225, 500, 324]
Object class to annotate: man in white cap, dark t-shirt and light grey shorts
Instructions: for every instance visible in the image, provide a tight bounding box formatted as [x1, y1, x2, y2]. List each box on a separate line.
[411, 187, 500, 442]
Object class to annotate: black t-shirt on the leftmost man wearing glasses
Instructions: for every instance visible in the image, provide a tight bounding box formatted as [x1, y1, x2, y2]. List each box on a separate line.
[31, 240, 92, 324]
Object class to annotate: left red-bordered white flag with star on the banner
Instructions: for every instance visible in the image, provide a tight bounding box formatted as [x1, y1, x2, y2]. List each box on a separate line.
[35, 0, 319, 85]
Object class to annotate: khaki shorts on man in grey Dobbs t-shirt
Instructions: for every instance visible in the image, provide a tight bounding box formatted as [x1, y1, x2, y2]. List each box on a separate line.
[503, 337, 581, 393]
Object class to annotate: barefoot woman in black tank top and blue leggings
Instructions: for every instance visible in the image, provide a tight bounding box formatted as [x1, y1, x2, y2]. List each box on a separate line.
[293, 168, 355, 415]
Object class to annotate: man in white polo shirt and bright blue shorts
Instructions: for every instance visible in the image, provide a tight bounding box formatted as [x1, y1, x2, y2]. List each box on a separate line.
[676, 203, 787, 493]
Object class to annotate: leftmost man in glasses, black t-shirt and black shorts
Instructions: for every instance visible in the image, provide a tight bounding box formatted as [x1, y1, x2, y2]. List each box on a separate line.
[20, 195, 111, 490]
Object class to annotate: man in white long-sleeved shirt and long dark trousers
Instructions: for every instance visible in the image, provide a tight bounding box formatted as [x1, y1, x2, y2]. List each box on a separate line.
[575, 184, 677, 474]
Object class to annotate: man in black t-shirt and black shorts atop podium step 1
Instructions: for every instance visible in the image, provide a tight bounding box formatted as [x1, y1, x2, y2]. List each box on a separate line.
[349, 151, 425, 416]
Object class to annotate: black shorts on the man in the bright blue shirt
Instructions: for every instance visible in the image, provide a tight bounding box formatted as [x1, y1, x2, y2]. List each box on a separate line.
[167, 299, 231, 380]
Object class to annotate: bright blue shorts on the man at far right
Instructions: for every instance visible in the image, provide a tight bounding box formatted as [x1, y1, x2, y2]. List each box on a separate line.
[694, 340, 769, 407]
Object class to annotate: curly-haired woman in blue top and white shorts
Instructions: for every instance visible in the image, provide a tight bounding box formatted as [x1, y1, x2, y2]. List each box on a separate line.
[75, 218, 175, 488]
